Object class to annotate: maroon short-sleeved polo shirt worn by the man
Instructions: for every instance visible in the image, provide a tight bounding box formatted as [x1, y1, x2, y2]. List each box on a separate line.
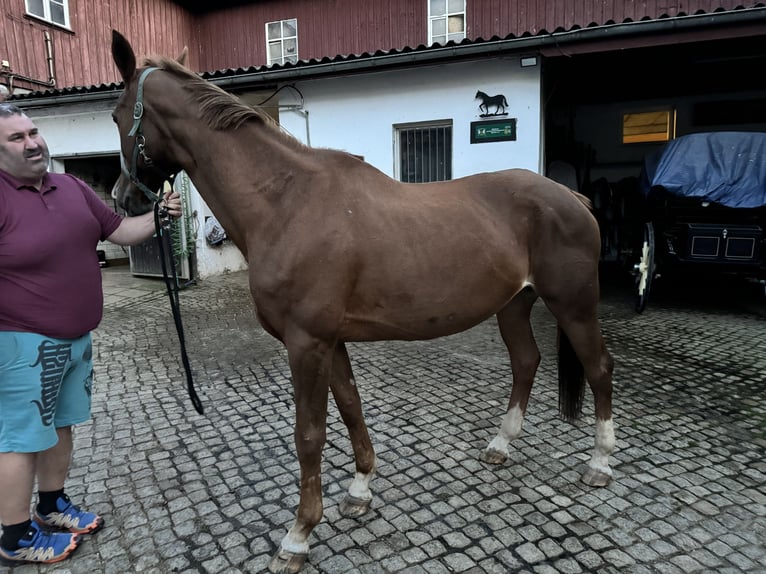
[0, 170, 122, 339]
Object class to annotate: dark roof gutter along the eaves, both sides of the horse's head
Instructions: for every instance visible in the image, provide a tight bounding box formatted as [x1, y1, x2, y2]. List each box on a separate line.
[14, 6, 766, 107]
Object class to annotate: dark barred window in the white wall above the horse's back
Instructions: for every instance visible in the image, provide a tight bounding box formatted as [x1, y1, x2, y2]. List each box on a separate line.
[394, 121, 452, 183]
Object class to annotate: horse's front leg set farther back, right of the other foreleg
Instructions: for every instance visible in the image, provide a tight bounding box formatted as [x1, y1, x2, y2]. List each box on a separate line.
[330, 343, 375, 517]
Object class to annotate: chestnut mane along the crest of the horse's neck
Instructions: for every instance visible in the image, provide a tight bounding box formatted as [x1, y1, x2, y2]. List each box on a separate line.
[143, 56, 305, 151]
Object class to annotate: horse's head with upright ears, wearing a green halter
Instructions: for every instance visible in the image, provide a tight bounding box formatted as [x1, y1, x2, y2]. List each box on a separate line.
[112, 30, 187, 215]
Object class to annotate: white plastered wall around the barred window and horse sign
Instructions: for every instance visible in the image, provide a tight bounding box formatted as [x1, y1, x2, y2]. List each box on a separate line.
[279, 57, 542, 178]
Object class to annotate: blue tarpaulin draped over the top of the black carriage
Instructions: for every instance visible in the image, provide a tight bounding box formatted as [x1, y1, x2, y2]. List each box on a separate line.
[641, 132, 766, 208]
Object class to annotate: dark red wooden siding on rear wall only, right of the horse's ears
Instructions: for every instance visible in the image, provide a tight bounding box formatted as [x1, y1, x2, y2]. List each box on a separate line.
[197, 0, 760, 71]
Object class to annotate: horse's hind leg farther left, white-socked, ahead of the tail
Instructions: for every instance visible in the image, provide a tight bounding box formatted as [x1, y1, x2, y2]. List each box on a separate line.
[481, 288, 540, 464]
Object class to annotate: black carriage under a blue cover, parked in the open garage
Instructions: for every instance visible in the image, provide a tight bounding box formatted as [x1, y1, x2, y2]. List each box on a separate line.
[633, 132, 766, 313]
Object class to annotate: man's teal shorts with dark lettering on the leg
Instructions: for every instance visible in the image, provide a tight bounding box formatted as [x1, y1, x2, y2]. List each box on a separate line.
[0, 331, 93, 452]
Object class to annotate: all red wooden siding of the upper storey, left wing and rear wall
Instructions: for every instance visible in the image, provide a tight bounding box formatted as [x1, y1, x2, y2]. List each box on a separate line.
[0, 0, 760, 90]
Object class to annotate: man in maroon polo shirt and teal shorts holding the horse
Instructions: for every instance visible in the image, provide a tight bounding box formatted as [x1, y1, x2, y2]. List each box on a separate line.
[0, 102, 181, 563]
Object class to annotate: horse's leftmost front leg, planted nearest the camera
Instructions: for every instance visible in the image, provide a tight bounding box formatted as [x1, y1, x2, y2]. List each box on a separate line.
[269, 333, 333, 574]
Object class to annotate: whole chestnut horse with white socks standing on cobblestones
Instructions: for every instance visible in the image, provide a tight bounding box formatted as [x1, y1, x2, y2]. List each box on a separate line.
[112, 32, 614, 573]
